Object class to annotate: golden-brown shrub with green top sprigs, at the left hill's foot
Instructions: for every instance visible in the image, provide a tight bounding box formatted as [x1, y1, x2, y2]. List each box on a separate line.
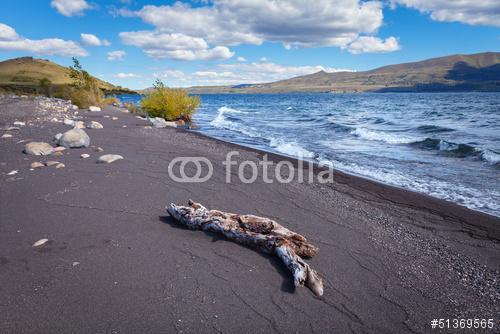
[69, 58, 104, 108]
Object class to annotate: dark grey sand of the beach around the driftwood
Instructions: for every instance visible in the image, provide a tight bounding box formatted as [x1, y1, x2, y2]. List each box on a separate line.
[0, 101, 500, 333]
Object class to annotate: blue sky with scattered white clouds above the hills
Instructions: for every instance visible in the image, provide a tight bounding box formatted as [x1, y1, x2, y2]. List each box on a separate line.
[0, 0, 500, 89]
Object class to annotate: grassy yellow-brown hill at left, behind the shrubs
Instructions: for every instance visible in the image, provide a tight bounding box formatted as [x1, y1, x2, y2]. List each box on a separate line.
[0, 57, 132, 93]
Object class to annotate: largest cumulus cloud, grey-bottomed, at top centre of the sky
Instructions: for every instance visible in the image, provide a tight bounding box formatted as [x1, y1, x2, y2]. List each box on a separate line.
[118, 0, 398, 59]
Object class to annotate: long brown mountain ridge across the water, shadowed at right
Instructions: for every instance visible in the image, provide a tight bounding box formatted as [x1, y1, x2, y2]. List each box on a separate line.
[189, 52, 500, 94]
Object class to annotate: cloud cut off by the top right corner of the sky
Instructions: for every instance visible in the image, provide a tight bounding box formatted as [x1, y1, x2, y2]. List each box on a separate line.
[391, 0, 500, 27]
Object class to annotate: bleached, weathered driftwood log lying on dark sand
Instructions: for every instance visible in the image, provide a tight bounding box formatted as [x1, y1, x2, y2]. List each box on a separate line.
[167, 200, 323, 296]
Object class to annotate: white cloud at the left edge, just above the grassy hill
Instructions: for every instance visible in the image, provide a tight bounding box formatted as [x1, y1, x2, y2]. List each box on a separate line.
[0, 23, 88, 56]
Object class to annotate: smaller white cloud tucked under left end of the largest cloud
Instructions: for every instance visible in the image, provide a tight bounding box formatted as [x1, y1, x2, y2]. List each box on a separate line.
[120, 30, 234, 60]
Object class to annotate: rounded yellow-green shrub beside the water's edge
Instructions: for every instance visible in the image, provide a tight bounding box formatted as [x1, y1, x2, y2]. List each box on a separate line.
[141, 80, 201, 122]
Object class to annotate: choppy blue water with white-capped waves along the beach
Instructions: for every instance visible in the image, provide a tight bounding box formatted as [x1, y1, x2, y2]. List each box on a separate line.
[120, 93, 500, 216]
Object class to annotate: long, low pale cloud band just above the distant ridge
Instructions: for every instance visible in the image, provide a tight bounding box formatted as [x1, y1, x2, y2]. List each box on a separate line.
[154, 62, 350, 87]
